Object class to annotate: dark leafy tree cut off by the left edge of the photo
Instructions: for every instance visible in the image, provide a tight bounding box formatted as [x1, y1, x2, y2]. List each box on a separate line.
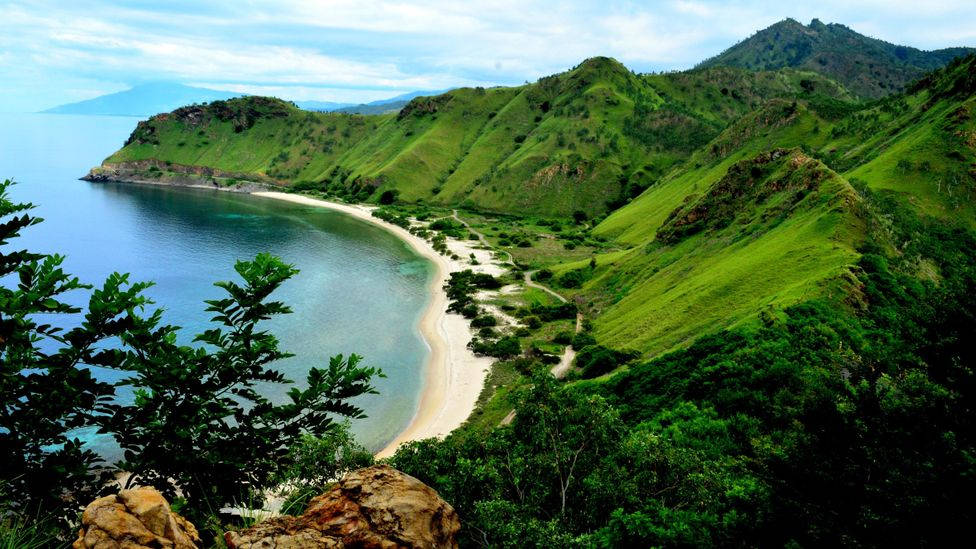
[0, 180, 149, 519]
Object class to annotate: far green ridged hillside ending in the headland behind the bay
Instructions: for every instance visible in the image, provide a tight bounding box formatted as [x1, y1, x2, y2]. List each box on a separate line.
[97, 58, 851, 216]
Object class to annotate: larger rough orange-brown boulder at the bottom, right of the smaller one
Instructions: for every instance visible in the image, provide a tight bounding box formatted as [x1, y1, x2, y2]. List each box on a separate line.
[224, 465, 461, 549]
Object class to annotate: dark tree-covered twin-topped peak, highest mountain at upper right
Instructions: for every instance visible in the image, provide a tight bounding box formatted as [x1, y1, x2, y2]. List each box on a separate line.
[698, 19, 976, 98]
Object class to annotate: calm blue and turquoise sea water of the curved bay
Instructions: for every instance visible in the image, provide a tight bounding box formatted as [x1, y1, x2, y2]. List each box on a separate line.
[0, 114, 432, 458]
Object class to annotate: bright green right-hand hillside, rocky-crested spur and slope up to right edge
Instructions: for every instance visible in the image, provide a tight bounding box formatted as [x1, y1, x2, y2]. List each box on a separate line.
[554, 56, 976, 355]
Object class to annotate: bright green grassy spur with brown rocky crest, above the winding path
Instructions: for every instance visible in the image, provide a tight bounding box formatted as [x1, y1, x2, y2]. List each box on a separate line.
[572, 149, 864, 355]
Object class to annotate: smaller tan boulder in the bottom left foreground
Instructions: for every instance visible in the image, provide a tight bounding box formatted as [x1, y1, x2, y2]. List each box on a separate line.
[72, 488, 201, 549]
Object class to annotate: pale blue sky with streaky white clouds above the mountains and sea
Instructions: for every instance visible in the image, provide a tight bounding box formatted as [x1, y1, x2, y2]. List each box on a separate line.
[0, 0, 976, 112]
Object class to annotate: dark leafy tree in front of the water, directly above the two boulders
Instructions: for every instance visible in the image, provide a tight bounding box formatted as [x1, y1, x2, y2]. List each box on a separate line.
[101, 254, 382, 520]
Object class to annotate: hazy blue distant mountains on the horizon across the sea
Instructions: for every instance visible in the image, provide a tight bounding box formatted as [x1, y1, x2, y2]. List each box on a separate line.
[42, 82, 447, 117]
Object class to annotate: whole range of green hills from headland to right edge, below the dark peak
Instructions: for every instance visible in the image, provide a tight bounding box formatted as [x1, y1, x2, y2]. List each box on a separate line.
[86, 34, 976, 356]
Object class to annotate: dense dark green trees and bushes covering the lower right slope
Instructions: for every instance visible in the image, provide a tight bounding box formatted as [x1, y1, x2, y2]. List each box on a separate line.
[393, 196, 976, 547]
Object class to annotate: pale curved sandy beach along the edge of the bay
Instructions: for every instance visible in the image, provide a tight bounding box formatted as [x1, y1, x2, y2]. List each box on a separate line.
[251, 191, 505, 458]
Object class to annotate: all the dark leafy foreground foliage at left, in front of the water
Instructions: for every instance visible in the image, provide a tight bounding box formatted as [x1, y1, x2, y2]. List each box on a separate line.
[0, 181, 382, 535]
